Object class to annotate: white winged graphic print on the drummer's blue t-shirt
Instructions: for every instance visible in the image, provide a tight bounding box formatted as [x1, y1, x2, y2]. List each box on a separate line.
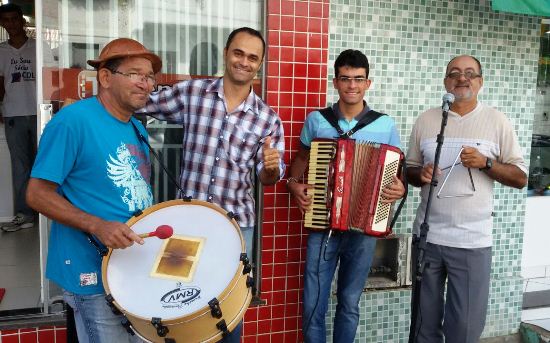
[106, 143, 153, 212]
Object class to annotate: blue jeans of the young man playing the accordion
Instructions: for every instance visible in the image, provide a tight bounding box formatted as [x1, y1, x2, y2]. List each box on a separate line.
[302, 231, 376, 343]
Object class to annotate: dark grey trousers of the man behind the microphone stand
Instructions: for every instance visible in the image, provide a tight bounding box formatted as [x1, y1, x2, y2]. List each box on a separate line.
[413, 243, 492, 343]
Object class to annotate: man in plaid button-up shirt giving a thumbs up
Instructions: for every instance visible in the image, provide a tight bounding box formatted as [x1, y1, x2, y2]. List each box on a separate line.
[144, 27, 285, 342]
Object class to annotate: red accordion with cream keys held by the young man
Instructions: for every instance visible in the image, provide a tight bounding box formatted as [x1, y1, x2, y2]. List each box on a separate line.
[304, 139, 404, 237]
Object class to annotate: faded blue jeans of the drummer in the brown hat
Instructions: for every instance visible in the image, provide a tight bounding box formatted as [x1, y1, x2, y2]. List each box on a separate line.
[63, 291, 143, 343]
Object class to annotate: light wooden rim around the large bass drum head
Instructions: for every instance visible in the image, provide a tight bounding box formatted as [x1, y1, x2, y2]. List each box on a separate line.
[101, 199, 250, 325]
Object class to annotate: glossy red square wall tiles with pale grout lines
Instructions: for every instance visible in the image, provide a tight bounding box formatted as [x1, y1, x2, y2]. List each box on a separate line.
[0, 0, 329, 343]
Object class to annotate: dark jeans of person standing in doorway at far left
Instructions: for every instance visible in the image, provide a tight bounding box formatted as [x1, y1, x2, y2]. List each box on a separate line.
[4, 116, 36, 216]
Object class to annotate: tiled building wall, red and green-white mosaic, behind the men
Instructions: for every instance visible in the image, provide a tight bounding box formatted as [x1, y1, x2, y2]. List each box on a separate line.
[0, 0, 540, 343]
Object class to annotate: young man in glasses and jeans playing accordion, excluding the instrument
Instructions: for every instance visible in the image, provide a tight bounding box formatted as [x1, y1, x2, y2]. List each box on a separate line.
[287, 50, 405, 343]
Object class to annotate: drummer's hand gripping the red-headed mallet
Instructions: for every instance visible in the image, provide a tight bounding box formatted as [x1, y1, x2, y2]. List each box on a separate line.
[90, 220, 143, 249]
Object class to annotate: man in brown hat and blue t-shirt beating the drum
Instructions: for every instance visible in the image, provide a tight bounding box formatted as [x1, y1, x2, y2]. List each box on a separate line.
[27, 38, 162, 343]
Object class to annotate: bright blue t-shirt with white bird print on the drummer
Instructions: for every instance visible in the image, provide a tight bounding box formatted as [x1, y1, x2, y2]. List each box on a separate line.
[31, 97, 153, 295]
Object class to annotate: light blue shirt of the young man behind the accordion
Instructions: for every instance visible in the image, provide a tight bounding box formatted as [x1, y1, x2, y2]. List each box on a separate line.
[300, 103, 401, 149]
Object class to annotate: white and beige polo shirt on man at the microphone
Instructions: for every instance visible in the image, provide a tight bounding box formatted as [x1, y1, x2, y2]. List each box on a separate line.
[407, 103, 527, 248]
